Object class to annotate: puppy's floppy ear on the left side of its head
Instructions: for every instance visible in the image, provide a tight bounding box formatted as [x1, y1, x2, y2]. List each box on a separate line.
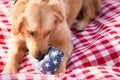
[12, 15, 24, 35]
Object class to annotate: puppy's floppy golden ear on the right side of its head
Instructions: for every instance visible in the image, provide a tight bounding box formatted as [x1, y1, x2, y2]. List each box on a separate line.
[49, 0, 64, 23]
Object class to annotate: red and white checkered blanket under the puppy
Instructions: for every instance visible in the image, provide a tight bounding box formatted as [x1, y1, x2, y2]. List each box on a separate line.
[0, 0, 120, 80]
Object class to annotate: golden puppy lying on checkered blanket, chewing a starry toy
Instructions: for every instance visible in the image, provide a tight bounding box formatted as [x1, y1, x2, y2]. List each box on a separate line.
[3, 0, 100, 73]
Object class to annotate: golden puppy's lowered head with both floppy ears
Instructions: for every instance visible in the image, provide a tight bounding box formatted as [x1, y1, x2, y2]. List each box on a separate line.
[12, 1, 64, 60]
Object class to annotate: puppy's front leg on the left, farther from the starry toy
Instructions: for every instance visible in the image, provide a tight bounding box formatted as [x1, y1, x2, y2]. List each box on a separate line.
[3, 39, 25, 73]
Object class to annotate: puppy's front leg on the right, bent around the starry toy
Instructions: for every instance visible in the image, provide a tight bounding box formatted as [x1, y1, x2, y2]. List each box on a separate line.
[51, 27, 73, 74]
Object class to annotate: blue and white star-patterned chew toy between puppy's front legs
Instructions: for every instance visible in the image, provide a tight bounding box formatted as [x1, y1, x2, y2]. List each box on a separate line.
[33, 46, 64, 74]
